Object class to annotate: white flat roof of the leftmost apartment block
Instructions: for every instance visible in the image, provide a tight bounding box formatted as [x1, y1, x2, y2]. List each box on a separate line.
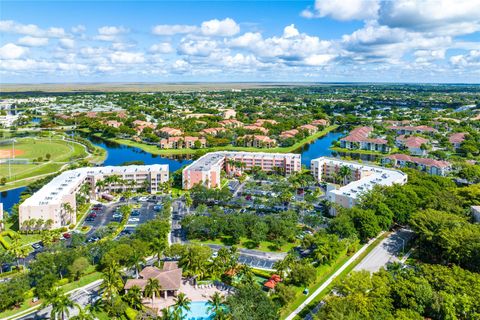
[21, 164, 168, 206]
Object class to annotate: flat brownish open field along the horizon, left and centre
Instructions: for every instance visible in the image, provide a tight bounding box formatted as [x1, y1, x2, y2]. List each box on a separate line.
[0, 82, 326, 92]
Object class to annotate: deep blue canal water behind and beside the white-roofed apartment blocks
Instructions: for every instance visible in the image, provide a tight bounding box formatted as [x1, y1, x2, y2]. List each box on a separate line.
[0, 130, 376, 211]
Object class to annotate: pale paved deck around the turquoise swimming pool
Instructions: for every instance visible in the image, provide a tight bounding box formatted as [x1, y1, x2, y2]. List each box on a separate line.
[143, 281, 228, 314]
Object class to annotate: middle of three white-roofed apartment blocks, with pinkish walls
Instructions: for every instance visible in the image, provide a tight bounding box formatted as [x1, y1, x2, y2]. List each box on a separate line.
[182, 151, 301, 189]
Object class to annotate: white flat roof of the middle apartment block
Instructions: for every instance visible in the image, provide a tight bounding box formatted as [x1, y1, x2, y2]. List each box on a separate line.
[184, 151, 301, 171]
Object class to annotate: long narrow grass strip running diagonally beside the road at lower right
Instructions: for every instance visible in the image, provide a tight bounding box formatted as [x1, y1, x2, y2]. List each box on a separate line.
[292, 232, 390, 319]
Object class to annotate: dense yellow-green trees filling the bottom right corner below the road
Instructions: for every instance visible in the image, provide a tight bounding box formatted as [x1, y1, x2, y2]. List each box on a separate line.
[317, 264, 480, 320]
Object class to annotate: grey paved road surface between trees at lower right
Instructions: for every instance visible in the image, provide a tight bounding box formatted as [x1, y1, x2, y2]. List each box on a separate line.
[353, 229, 413, 272]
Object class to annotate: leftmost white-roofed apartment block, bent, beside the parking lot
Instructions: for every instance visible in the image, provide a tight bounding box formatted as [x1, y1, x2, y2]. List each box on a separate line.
[19, 164, 169, 229]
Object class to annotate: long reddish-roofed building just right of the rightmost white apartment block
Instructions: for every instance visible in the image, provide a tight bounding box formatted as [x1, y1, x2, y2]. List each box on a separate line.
[382, 154, 452, 176]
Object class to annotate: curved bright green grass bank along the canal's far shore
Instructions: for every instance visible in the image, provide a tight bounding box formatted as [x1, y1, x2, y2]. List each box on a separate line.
[94, 125, 338, 155]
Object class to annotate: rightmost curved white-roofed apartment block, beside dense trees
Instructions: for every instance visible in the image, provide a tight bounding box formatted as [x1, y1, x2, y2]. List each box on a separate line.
[310, 157, 407, 214]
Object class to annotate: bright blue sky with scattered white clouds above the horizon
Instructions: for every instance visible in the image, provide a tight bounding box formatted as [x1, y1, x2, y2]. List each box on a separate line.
[0, 0, 480, 83]
